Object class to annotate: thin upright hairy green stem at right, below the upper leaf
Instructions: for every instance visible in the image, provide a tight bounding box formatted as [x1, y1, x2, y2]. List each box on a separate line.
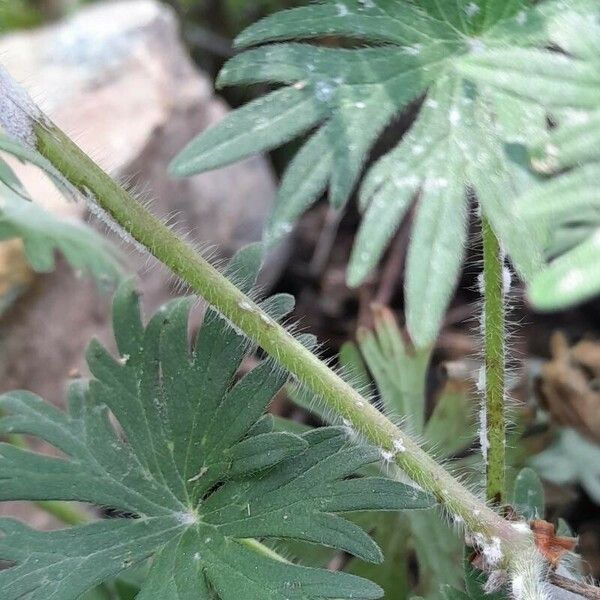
[481, 217, 506, 505]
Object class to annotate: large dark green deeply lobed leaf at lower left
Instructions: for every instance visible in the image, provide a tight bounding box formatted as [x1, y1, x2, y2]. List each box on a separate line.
[0, 247, 432, 600]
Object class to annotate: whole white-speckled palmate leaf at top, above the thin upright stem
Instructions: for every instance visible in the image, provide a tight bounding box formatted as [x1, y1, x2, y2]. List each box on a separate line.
[172, 0, 587, 347]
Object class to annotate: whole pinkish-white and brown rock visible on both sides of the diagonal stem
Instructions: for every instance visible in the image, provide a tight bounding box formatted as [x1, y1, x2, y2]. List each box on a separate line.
[0, 0, 285, 402]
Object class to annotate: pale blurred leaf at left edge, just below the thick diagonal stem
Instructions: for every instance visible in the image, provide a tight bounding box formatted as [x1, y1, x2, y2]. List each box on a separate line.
[0, 134, 123, 288]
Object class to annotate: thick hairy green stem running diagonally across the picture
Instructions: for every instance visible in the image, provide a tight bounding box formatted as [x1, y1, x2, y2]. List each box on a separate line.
[0, 68, 543, 600]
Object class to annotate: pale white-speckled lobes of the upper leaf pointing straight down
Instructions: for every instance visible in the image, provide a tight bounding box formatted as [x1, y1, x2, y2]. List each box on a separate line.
[349, 72, 538, 347]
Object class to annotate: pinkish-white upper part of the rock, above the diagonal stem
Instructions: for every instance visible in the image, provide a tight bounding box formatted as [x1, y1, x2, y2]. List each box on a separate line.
[0, 0, 285, 292]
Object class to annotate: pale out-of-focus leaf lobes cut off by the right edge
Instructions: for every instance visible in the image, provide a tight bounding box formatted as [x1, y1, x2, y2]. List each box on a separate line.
[460, 3, 600, 310]
